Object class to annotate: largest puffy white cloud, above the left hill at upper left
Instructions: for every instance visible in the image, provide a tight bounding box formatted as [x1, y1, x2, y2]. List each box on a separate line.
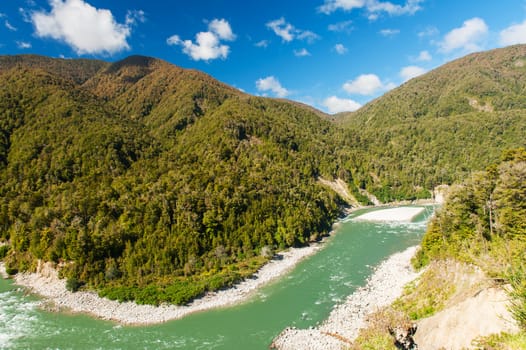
[30, 0, 139, 55]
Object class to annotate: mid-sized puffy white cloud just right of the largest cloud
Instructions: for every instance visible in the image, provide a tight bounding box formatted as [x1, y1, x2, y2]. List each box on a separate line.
[166, 19, 236, 61]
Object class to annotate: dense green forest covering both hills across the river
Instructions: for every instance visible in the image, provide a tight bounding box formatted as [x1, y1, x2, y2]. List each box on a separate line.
[0, 46, 526, 304]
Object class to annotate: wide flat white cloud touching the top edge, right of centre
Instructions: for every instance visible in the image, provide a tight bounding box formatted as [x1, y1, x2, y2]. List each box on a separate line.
[318, 0, 423, 20]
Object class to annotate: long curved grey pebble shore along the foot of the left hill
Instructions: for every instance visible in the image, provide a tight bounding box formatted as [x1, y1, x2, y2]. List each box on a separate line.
[0, 243, 323, 325]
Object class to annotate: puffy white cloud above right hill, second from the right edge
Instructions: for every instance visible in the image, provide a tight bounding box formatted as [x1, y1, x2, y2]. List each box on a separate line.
[440, 17, 488, 52]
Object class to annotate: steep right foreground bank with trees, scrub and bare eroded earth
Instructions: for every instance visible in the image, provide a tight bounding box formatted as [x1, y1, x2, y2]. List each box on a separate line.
[351, 148, 526, 350]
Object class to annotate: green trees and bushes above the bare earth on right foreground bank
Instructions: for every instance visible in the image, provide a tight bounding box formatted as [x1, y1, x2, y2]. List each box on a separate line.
[415, 148, 526, 330]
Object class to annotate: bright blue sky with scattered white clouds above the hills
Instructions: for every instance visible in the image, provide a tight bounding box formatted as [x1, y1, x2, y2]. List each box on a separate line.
[0, 0, 526, 113]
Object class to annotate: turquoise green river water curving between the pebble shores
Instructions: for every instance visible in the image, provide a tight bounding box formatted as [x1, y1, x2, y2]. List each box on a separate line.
[0, 207, 433, 350]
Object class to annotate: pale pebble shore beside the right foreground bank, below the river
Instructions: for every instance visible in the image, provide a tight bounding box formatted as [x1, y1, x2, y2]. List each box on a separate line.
[271, 246, 419, 350]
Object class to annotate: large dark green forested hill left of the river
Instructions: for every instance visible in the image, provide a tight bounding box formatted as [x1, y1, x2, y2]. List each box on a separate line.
[0, 52, 356, 303]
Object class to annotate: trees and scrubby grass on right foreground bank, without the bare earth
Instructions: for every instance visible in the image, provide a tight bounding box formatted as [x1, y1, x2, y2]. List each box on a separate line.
[348, 148, 526, 349]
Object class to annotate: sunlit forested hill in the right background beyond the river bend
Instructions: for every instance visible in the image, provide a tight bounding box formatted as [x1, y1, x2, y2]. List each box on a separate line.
[336, 45, 526, 201]
